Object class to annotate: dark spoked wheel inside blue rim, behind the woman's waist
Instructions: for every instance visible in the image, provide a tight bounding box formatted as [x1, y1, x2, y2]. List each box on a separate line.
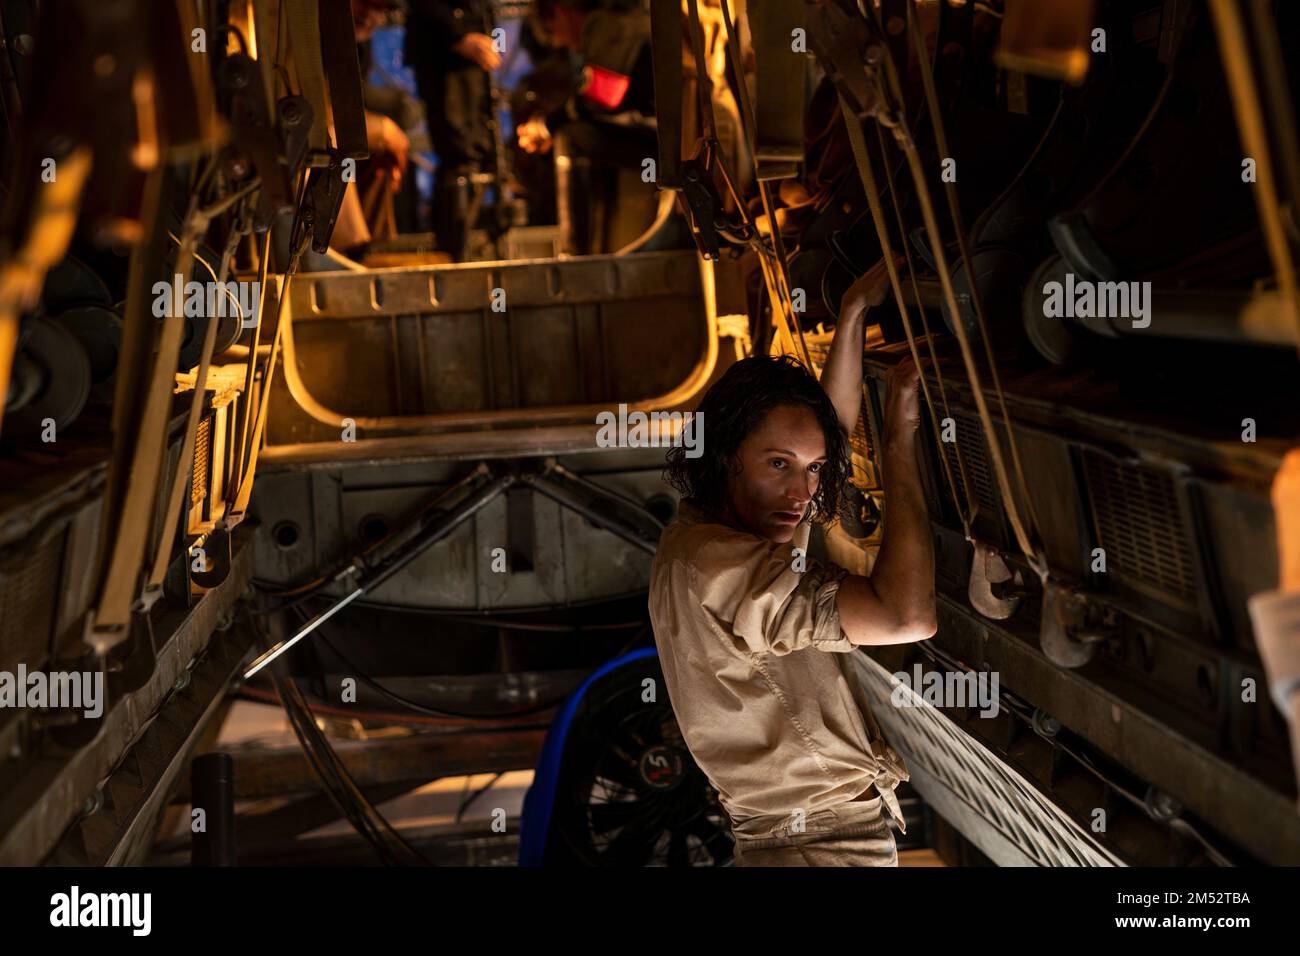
[547, 658, 733, 866]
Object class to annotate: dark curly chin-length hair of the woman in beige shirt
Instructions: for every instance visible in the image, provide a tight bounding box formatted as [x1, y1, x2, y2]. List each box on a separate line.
[663, 355, 853, 524]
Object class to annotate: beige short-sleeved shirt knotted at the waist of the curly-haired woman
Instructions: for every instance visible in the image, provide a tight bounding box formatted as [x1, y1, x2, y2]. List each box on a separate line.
[650, 501, 907, 836]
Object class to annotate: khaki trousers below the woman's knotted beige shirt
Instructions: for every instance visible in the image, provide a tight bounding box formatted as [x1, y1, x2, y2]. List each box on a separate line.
[733, 797, 898, 866]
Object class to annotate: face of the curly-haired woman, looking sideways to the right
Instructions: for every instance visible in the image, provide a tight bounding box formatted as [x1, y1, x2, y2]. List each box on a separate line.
[728, 405, 826, 544]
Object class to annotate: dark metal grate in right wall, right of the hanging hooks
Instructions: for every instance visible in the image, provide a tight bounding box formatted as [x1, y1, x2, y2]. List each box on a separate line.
[1083, 451, 1197, 604]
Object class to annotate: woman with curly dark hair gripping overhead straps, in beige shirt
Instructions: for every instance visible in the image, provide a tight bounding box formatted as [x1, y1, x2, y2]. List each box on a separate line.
[650, 263, 937, 866]
